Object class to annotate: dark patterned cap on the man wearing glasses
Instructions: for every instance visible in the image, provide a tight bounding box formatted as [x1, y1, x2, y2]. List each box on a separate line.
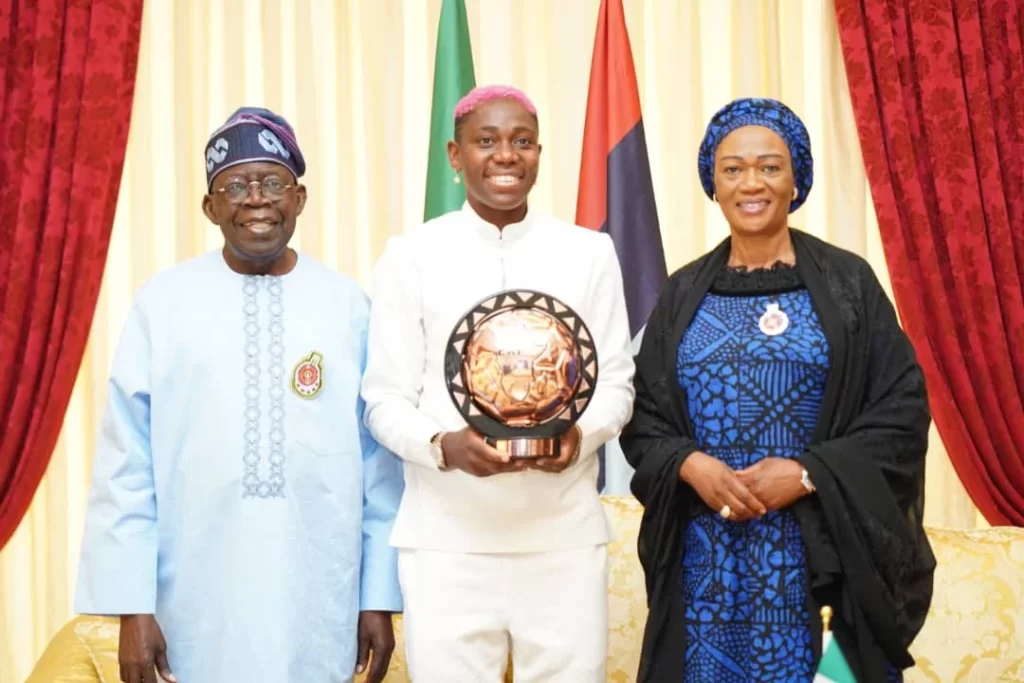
[206, 106, 306, 190]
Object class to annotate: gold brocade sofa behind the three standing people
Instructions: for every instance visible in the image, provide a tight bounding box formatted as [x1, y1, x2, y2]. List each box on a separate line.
[26, 497, 1024, 683]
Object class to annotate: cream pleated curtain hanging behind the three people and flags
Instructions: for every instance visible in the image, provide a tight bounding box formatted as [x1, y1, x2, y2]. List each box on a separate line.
[0, 0, 979, 683]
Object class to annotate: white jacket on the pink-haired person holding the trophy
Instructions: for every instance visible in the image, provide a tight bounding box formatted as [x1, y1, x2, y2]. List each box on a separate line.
[362, 205, 634, 553]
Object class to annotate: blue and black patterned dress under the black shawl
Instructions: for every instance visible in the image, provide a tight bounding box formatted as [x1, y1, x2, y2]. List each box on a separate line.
[677, 266, 828, 683]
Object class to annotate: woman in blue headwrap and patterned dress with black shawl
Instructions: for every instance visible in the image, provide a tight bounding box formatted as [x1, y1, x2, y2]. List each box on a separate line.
[622, 99, 935, 683]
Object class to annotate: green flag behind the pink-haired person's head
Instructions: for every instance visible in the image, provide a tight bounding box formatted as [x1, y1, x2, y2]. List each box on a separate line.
[423, 0, 476, 220]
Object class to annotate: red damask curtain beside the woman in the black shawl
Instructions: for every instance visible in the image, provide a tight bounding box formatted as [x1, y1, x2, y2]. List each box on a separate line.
[836, 0, 1024, 526]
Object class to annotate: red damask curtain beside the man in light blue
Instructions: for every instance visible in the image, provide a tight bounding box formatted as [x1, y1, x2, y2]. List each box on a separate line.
[0, 0, 145, 548]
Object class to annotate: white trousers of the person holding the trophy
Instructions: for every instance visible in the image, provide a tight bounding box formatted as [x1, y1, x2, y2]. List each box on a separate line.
[398, 545, 608, 683]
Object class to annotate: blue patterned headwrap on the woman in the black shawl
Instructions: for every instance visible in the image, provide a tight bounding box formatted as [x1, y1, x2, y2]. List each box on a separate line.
[697, 97, 814, 213]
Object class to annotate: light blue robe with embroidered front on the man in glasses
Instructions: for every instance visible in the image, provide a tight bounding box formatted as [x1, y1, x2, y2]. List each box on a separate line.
[75, 252, 402, 683]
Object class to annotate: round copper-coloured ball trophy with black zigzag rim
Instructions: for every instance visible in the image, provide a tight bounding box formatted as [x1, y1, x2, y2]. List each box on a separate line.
[444, 290, 597, 458]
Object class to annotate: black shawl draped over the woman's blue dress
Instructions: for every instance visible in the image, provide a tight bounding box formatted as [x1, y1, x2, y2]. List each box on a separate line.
[621, 230, 935, 683]
